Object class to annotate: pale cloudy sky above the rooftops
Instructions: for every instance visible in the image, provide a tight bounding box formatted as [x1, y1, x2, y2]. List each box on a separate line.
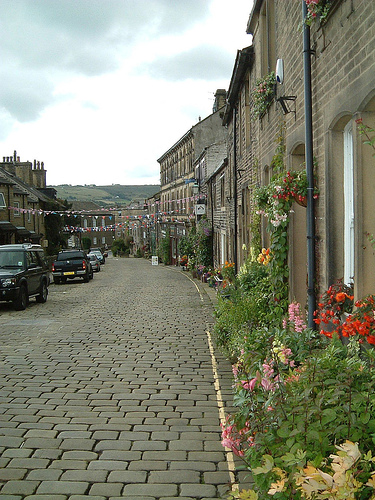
[0, 0, 252, 185]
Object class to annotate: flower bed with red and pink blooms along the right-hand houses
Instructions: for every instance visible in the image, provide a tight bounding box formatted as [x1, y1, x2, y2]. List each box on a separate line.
[214, 264, 375, 500]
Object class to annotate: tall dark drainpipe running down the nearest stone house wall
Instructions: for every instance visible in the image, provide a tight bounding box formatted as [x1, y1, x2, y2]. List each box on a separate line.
[302, 0, 316, 329]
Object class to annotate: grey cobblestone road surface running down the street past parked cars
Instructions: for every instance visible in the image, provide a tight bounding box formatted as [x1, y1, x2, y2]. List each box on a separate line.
[0, 257, 239, 500]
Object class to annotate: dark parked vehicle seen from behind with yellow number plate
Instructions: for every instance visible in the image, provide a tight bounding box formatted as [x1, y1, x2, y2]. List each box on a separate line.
[52, 250, 94, 284]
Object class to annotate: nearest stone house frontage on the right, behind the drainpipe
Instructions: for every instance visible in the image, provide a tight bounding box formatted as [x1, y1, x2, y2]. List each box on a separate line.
[220, 0, 375, 310]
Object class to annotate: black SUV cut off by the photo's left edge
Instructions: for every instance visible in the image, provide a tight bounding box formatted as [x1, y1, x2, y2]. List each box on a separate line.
[0, 243, 50, 311]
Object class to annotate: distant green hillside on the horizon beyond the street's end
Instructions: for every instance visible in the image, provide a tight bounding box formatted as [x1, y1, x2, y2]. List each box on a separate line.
[48, 184, 160, 205]
